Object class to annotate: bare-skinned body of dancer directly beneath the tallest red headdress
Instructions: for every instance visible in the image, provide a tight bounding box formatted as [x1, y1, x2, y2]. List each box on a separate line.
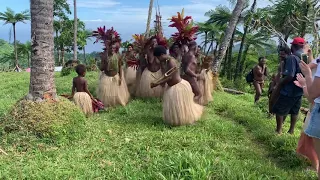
[181, 41, 202, 102]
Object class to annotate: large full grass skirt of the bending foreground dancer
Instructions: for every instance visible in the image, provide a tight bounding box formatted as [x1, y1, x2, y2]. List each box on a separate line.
[163, 80, 203, 126]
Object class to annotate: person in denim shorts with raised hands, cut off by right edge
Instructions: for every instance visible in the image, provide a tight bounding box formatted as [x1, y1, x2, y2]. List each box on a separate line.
[300, 60, 320, 179]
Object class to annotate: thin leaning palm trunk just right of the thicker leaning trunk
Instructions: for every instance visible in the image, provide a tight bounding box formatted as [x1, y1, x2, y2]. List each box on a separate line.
[233, 0, 257, 80]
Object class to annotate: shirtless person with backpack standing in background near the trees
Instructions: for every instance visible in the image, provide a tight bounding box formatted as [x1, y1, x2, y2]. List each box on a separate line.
[253, 57, 267, 103]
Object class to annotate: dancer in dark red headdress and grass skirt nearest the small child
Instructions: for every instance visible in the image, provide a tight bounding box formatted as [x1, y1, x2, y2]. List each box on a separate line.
[93, 27, 130, 107]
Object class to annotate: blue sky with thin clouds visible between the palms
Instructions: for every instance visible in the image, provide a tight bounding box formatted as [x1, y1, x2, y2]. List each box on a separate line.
[0, 0, 269, 52]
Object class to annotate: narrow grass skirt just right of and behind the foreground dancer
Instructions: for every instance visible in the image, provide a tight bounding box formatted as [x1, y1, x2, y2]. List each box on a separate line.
[197, 70, 213, 105]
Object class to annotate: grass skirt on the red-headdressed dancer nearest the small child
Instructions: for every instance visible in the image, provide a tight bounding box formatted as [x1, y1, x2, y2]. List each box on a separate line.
[97, 74, 130, 107]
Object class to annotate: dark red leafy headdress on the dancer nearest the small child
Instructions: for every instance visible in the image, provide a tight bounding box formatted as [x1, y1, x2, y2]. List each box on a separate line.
[92, 26, 121, 49]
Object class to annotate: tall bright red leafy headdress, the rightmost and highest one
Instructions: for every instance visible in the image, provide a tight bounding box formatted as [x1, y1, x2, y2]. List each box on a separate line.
[169, 9, 199, 44]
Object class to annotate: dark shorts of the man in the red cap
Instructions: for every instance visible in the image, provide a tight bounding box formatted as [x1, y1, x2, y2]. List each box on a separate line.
[272, 95, 302, 116]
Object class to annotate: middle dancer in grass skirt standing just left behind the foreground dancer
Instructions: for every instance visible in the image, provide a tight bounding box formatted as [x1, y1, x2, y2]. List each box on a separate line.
[136, 36, 164, 98]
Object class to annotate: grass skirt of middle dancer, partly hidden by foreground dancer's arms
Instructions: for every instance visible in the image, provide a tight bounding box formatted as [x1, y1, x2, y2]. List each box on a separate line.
[136, 68, 164, 97]
